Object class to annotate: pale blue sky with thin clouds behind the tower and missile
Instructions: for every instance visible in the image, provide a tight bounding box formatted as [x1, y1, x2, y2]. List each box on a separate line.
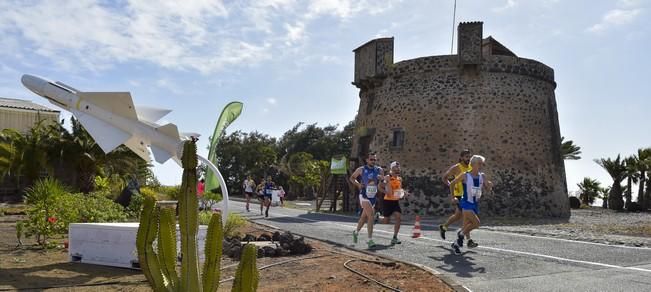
[0, 0, 651, 198]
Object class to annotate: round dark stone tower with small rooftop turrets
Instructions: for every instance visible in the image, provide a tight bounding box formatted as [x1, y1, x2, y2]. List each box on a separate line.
[351, 22, 570, 217]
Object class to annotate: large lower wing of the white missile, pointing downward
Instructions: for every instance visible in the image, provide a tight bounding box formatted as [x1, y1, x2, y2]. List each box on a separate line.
[76, 112, 131, 153]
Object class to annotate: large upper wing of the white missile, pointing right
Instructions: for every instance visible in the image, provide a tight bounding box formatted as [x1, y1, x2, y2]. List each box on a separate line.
[77, 92, 138, 121]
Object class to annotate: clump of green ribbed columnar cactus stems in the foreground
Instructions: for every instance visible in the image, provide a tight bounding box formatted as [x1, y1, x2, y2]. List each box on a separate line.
[136, 141, 258, 292]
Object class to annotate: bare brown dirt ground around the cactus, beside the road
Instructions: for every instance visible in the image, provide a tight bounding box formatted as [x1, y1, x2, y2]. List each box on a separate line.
[0, 216, 452, 291]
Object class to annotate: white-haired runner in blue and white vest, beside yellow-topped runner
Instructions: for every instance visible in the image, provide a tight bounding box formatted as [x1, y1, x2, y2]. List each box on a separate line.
[450, 155, 493, 254]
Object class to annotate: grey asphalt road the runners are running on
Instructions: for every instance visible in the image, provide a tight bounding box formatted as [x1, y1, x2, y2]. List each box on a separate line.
[229, 201, 651, 292]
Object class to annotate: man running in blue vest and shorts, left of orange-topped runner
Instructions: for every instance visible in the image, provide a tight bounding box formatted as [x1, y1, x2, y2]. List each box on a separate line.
[350, 153, 384, 248]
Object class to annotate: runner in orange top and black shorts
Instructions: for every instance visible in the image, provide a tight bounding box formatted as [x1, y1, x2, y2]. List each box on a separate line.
[382, 161, 406, 244]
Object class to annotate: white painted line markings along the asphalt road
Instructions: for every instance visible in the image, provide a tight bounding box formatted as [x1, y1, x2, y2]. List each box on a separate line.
[243, 210, 651, 273]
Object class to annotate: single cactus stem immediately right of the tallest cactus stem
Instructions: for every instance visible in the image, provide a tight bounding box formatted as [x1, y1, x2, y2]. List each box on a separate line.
[202, 213, 224, 291]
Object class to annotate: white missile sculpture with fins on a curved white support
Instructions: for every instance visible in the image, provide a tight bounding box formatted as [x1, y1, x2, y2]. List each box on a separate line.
[21, 74, 228, 223]
